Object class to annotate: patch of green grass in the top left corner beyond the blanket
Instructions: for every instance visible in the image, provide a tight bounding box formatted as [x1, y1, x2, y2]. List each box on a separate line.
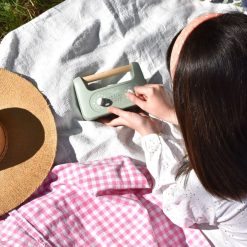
[0, 0, 62, 40]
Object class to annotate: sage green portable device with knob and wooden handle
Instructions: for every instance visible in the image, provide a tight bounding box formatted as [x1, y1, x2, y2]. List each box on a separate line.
[73, 62, 147, 120]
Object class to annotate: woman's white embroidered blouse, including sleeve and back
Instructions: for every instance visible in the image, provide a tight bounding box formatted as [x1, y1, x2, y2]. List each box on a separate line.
[142, 124, 247, 247]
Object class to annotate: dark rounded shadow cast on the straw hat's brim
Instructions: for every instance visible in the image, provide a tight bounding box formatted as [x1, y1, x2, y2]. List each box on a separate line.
[0, 108, 45, 171]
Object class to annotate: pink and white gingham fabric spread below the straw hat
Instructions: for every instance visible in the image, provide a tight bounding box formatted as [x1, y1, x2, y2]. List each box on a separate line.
[0, 156, 210, 247]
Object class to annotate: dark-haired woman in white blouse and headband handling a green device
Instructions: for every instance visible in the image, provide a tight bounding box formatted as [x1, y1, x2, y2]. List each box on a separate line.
[107, 13, 247, 246]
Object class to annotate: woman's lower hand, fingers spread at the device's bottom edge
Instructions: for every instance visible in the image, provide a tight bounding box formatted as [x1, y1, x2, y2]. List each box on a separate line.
[101, 106, 161, 136]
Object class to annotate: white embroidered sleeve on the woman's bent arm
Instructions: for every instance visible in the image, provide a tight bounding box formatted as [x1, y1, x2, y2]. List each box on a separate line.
[142, 125, 216, 227]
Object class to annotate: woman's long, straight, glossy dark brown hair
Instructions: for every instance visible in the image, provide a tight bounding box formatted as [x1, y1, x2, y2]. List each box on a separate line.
[168, 13, 247, 200]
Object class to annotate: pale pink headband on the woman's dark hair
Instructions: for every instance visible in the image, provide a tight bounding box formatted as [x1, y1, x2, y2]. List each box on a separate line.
[170, 13, 221, 78]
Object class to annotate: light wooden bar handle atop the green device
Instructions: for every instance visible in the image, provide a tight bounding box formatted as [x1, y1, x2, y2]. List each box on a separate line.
[82, 64, 131, 82]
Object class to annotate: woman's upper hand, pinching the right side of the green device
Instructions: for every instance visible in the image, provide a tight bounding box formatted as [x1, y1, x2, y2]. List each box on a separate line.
[126, 84, 178, 124]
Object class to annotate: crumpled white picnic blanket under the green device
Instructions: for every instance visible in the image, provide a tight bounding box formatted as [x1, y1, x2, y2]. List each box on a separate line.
[0, 0, 236, 166]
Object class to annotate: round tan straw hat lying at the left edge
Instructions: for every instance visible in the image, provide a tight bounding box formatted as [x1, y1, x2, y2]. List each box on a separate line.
[0, 69, 57, 215]
